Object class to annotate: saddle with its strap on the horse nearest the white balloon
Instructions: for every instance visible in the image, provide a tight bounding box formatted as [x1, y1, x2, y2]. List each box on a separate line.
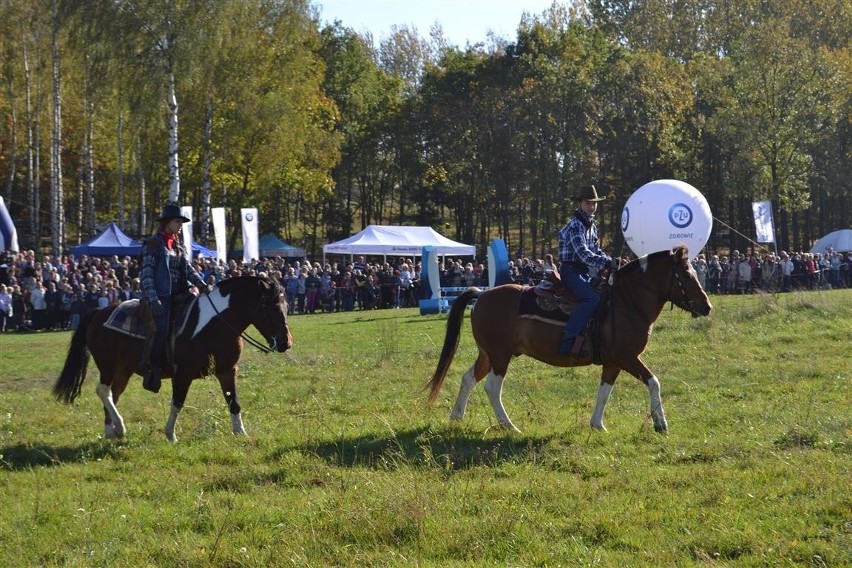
[518, 271, 611, 365]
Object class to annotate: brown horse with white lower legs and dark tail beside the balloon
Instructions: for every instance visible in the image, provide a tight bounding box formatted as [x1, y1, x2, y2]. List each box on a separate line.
[428, 246, 712, 432]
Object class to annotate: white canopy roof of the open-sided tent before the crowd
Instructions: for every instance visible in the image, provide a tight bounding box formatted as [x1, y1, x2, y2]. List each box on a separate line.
[322, 225, 476, 256]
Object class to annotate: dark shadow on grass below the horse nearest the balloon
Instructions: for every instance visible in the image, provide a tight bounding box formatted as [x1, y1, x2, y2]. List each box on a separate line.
[273, 427, 565, 471]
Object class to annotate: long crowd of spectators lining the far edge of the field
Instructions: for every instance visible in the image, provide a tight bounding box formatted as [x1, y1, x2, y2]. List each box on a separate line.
[0, 245, 852, 332]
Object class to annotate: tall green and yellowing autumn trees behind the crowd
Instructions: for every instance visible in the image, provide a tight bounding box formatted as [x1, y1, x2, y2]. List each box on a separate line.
[0, 0, 852, 256]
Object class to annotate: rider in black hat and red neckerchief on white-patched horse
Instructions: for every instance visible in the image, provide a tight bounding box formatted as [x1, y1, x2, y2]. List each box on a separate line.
[139, 203, 212, 392]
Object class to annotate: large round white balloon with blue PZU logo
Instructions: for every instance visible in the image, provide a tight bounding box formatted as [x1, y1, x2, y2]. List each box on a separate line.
[621, 179, 713, 258]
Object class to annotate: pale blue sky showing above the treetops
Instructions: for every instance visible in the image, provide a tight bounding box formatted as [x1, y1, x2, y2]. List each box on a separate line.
[313, 0, 553, 48]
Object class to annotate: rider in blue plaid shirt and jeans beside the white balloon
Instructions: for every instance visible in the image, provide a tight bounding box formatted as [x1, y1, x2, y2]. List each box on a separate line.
[559, 185, 618, 358]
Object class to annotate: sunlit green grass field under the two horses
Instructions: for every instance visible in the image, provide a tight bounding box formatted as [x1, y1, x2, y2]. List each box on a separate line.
[0, 290, 852, 567]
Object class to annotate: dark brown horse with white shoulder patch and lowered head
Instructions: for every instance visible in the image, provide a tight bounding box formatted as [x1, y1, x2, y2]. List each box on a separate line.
[53, 276, 293, 442]
